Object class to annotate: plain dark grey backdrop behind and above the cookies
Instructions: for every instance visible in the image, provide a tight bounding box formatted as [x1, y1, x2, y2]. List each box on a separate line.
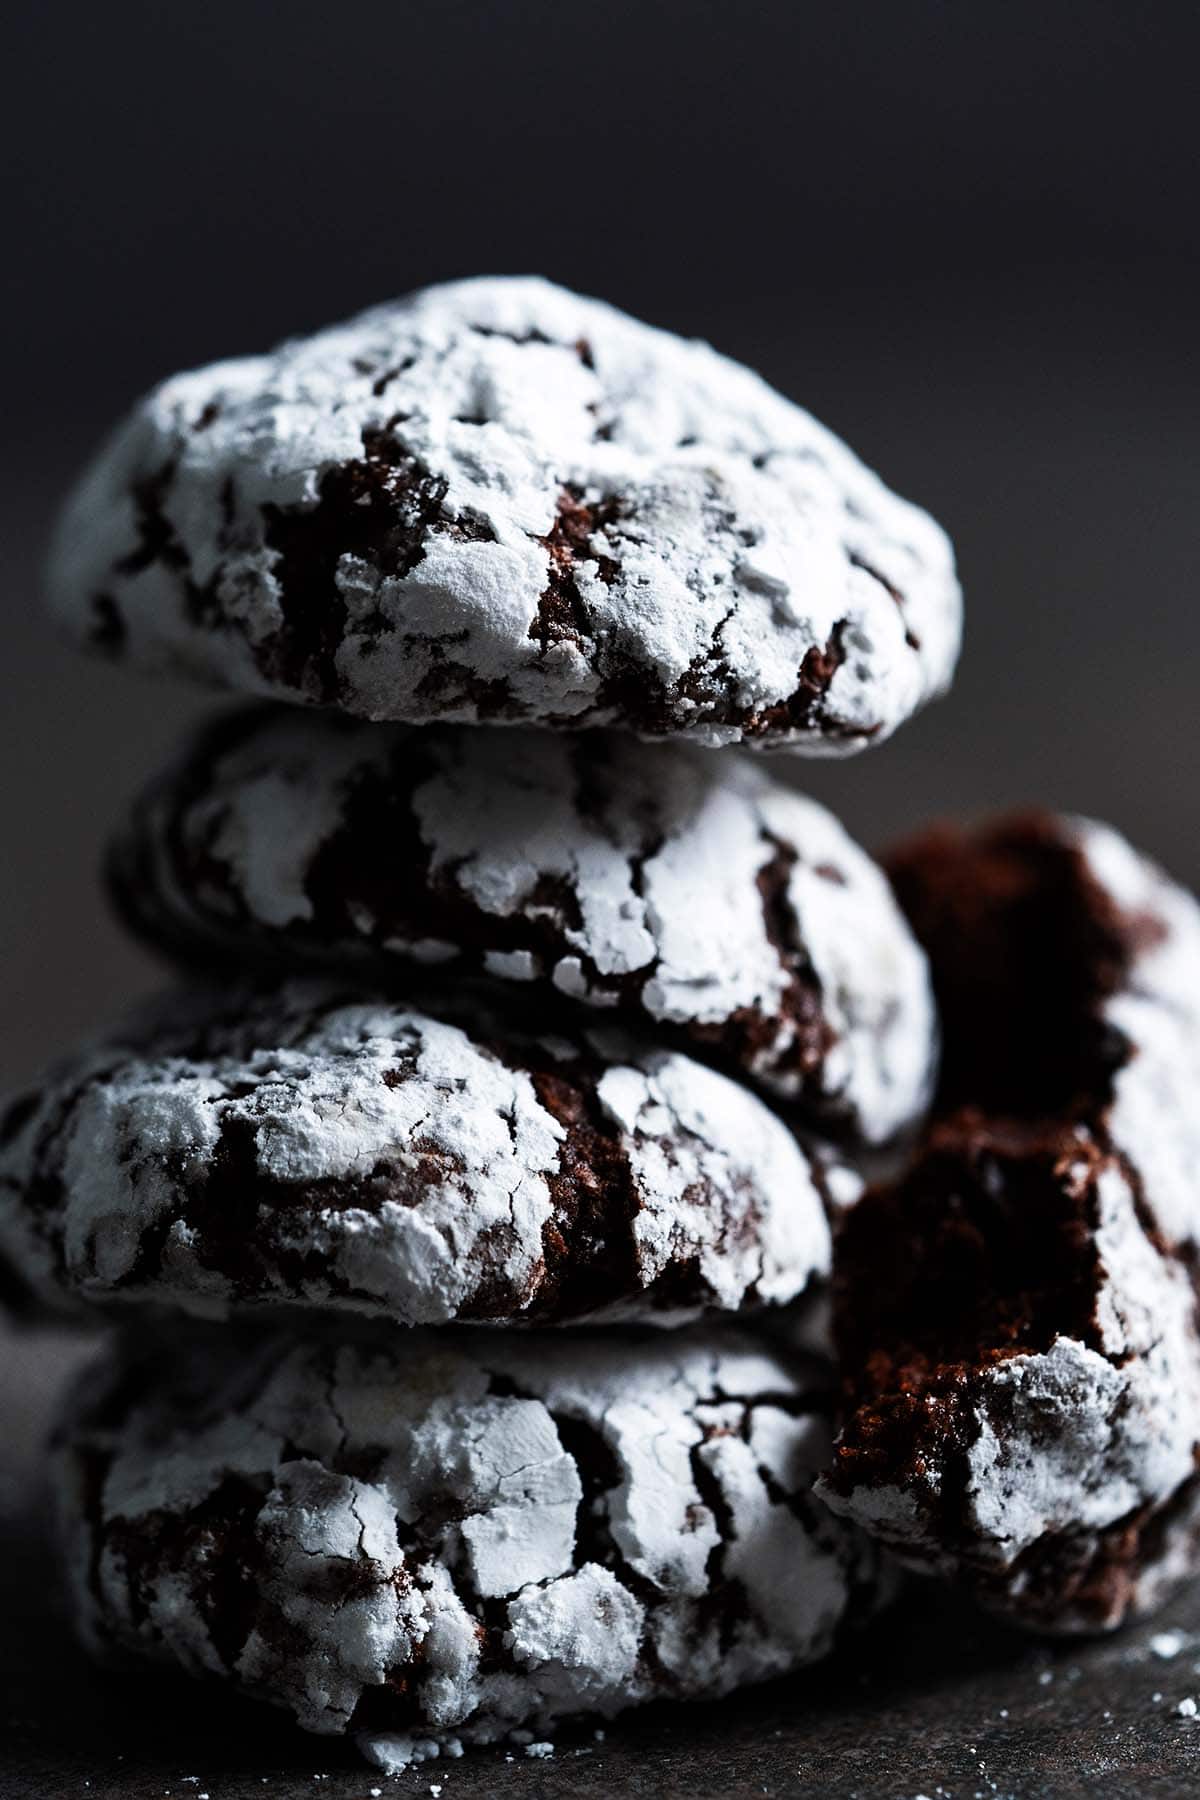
[0, 0, 1200, 1078]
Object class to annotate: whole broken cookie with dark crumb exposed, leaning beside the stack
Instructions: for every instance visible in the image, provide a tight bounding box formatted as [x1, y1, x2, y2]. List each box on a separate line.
[822, 815, 1200, 1631]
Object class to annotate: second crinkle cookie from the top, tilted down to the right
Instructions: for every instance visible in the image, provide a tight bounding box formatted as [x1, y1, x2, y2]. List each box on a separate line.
[110, 707, 937, 1143]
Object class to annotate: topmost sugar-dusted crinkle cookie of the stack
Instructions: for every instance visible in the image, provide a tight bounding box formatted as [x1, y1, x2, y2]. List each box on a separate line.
[50, 277, 961, 754]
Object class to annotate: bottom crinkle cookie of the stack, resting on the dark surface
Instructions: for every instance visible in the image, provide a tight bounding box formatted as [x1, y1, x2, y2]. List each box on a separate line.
[58, 1327, 887, 1768]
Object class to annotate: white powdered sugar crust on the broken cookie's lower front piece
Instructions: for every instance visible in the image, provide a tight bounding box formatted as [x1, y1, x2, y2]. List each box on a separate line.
[819, 1159, 1200, 1633]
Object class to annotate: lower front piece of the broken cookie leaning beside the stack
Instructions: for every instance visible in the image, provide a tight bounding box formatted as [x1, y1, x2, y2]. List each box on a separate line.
[820, 1132, 1200, 1633]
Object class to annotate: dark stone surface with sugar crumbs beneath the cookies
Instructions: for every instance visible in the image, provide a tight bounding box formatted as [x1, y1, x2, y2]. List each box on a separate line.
[0, 1337, 1200, 1800]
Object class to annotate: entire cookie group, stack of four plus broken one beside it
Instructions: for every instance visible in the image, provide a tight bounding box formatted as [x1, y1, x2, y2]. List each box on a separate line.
[14, 279, 1200, 1768]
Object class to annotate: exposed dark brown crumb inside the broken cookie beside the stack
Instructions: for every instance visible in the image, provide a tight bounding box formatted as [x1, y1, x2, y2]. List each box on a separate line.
[829, 814, 1162, 1622]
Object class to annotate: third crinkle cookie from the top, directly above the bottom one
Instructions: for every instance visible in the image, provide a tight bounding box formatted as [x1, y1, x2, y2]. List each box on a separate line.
[0, 983, 841, 1325]
